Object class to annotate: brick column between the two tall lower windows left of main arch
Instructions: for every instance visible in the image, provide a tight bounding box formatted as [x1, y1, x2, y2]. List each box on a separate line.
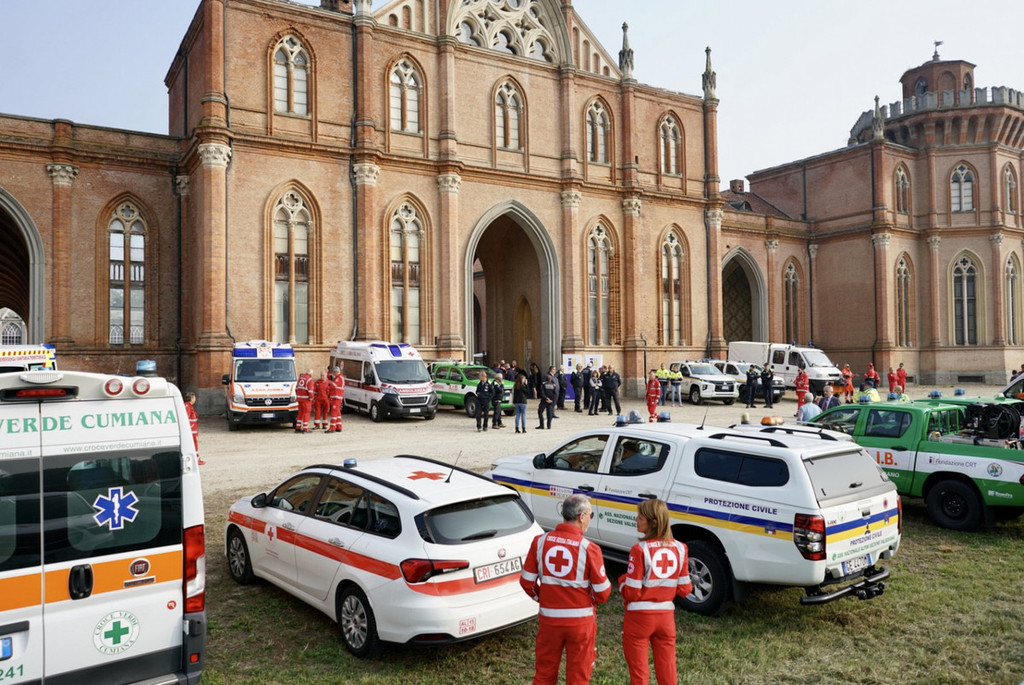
[352, 162, 382, 340]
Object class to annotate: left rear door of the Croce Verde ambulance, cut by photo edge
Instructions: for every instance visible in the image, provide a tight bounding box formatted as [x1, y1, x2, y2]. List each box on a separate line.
[0, 397, 43, 683]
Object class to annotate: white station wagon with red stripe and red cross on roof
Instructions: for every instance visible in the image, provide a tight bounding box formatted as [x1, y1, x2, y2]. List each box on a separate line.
[225, 456, 542, 657]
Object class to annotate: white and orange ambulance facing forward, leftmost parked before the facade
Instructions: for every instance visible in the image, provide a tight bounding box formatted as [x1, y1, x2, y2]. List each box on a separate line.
[220, 340, 299, 430]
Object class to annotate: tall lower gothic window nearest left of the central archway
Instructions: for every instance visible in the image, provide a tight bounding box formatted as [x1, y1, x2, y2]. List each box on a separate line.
[390, 203, 424, 345]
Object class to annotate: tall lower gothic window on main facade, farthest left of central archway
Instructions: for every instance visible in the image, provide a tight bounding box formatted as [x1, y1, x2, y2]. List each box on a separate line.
[273, 190, 312, 343]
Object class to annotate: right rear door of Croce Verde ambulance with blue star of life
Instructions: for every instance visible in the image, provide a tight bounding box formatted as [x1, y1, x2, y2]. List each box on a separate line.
[37, 396, 190, 682]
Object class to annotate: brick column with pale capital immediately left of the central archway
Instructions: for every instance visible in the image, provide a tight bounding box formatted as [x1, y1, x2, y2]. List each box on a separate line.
[434, 172, 466, 358]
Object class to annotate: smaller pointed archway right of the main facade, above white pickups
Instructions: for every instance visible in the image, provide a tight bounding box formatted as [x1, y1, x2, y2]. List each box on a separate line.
[722, 248, 768, 342]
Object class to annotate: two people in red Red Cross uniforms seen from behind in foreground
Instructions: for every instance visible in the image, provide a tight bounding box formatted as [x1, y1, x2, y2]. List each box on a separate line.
[519, 493, 692, 685]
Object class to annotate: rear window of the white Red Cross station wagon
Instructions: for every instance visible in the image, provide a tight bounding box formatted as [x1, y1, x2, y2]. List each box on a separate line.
[416, 495, 534, 545]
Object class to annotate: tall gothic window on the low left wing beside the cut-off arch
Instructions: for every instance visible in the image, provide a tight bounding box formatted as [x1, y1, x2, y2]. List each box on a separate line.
[108, 202, 146, 345]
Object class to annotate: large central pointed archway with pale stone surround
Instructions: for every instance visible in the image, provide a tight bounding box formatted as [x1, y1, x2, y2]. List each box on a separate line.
[466, 201, 561, 369]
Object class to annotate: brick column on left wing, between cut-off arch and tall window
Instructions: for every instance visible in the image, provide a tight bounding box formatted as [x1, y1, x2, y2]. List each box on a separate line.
[45, 164, 77, 343]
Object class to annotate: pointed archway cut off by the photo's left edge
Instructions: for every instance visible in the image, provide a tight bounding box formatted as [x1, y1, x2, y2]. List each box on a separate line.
[0, 187, 46, 343]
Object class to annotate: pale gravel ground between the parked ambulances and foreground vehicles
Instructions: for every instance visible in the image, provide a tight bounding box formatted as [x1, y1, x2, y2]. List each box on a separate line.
[193, 385, 999, 499]
